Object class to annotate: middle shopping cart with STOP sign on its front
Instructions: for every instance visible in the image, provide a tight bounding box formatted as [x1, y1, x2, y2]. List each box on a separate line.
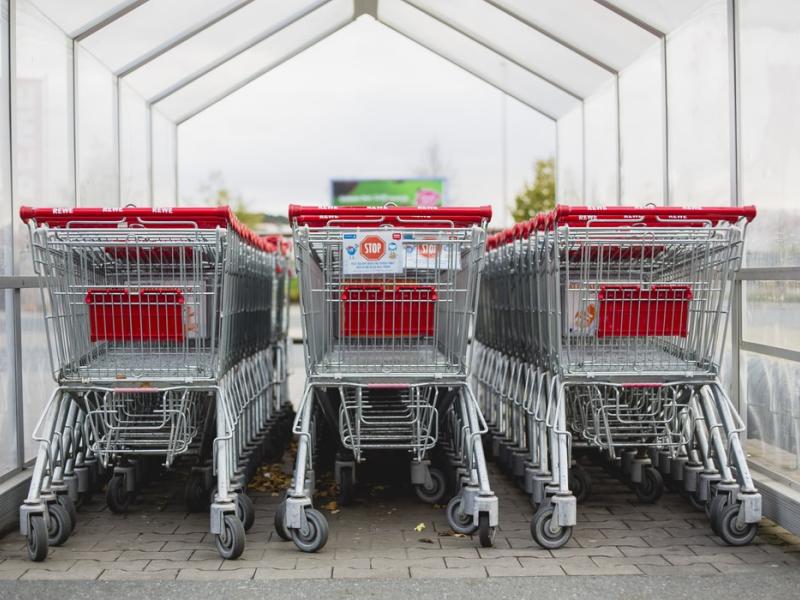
[275, 206, 497, 552]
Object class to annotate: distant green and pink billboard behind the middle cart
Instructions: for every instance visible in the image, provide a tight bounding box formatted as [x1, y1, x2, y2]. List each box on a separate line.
[331, 179, 445, 206]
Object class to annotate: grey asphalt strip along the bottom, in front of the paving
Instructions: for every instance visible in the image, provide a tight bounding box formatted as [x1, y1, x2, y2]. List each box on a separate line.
[0, 568, 800, 600]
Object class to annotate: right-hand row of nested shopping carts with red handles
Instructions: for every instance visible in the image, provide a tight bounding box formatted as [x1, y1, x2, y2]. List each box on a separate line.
[473, 206, 761, 548]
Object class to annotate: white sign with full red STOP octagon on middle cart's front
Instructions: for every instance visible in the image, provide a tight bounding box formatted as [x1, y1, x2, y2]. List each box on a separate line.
[342, 231, 403, 275]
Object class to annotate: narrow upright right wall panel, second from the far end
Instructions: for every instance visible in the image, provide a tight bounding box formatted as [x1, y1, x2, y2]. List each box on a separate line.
[584, 83, 619, 206]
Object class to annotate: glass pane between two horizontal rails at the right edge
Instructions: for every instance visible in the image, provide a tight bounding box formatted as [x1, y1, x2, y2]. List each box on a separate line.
[743, 281, 800, 350]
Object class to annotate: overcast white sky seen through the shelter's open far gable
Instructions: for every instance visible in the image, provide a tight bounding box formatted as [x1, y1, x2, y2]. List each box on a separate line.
[178, 17, 555, 226]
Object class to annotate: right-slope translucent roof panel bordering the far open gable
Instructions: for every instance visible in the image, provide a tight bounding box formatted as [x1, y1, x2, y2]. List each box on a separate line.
[378, 0, 580, 118]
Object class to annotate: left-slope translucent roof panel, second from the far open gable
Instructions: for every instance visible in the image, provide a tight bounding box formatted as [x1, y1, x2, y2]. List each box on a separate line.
[125, 0, 324, 99]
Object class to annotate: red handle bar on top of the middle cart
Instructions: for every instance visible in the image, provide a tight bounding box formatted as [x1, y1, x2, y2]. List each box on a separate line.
[289, 204, 492, 227]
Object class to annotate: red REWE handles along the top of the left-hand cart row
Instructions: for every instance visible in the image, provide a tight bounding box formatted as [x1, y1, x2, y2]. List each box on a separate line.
[19, 206, 276, 252]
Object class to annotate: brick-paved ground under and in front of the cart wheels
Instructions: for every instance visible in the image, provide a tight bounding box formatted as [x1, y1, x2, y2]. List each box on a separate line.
[0, 454, 800, 584]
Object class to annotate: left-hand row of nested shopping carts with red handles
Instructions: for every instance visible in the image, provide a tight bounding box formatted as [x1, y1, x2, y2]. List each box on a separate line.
[20, 207, 286, 560]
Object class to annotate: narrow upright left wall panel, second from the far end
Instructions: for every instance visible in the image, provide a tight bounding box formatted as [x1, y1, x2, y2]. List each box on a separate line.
[119, 81, 150, 206]
